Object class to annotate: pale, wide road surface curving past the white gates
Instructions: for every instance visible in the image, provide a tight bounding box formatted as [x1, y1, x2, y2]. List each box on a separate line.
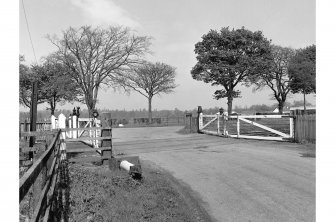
[113, 127, 315, 221]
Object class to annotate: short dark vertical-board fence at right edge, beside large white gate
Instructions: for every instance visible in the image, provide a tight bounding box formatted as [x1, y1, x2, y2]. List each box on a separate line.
[294, 115, 316, 143]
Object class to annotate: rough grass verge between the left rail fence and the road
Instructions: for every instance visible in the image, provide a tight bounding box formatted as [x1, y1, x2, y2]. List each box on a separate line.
[69, 163, 211, 222]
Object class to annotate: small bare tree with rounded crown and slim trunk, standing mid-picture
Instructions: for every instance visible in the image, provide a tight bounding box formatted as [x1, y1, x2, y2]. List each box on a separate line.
[118, 62, 177, 123]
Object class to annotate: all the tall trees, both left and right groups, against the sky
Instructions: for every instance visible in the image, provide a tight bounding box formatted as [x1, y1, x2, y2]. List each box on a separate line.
[19, 26, 316, 122]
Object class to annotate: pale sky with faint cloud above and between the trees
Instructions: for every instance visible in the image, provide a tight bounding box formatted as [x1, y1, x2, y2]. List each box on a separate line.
[19, 0, 316, 110]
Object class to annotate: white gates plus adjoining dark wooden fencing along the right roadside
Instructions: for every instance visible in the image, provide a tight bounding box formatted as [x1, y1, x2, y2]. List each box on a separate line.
[185, 107, 316, 143]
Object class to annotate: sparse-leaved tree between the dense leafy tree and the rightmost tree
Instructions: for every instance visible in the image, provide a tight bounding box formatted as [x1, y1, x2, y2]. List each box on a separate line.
[255, 45, 295, 113]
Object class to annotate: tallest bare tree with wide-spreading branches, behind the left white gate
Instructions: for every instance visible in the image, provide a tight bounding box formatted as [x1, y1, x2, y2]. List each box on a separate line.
[48, 26, 150, 115]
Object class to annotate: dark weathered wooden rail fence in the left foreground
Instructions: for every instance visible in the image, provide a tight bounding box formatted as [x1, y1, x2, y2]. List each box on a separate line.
[19, 130, 63, 221]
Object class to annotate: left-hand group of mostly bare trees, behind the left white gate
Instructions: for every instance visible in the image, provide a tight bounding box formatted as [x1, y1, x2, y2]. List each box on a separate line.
[20, 26, 176, 121]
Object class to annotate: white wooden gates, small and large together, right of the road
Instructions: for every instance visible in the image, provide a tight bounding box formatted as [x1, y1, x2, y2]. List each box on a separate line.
[199, 113, 294, 141]
